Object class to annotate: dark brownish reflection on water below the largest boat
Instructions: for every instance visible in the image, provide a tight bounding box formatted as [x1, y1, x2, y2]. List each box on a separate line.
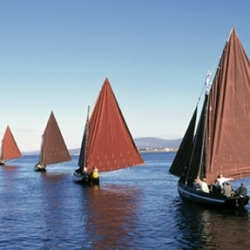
[175, 203, 250, 249]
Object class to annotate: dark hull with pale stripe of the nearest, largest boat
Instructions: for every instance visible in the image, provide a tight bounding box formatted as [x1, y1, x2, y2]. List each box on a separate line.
[178, 182, 249, 209]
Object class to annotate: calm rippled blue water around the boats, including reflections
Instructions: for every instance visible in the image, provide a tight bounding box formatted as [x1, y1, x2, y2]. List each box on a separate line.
[0, 153, 250, 250]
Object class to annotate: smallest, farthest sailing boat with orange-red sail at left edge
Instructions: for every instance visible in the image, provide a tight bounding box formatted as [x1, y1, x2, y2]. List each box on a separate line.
[0, 126, 22, 165]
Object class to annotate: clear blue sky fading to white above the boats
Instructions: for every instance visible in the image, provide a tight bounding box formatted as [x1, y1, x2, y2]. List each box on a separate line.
[0, 0, 250, 151]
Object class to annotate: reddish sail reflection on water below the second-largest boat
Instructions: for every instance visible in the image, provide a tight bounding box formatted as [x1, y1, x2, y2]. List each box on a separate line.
[83, 185, 139, 249]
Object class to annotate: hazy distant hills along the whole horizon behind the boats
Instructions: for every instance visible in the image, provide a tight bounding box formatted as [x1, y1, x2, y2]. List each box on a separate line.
[23, 137, 182, 155]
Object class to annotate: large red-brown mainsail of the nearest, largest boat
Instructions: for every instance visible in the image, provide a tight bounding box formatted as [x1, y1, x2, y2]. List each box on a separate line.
[206, 29, 250, 183]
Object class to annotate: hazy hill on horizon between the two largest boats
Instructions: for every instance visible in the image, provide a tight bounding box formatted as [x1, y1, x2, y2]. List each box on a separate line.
[134, 137, 182, 149]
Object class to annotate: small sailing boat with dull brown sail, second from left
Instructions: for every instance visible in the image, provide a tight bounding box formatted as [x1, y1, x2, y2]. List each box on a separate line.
[34, 112, 71, 172]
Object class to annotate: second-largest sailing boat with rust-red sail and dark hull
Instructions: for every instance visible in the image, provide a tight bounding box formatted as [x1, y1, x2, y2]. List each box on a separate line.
[73, 78, 144, 185]
